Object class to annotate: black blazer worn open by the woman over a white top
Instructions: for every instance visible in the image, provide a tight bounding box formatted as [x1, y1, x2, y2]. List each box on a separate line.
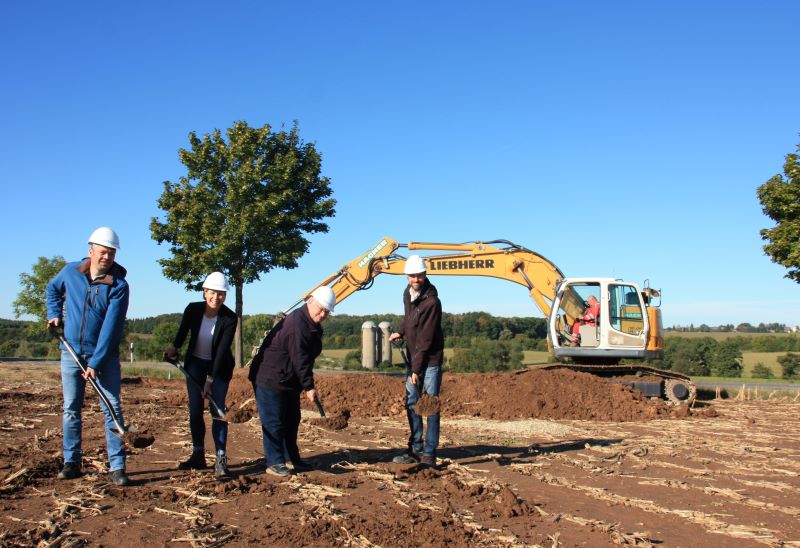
[172, 301, 236, 382]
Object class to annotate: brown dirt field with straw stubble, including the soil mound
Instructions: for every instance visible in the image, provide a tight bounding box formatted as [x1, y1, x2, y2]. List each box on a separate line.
[0, 364, 800, 547]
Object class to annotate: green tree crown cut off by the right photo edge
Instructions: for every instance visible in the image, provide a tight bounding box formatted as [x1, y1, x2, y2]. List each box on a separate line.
[757, 141, 800, 283]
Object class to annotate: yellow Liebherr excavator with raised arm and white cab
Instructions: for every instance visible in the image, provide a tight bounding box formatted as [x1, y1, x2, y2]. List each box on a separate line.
[290, 237, 697, 404]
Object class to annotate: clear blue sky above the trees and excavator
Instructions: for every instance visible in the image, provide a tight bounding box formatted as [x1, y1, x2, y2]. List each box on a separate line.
[0, 1, 800, 326]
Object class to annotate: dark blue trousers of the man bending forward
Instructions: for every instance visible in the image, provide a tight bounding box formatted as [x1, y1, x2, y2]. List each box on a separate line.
[256, 386, 300, 466]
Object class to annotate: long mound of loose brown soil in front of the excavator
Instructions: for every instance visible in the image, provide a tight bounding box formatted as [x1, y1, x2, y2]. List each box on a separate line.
[227, 369, 674, 421]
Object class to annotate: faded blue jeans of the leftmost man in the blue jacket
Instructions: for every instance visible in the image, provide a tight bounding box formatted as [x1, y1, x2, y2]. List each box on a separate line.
[61, 350, 125, 471]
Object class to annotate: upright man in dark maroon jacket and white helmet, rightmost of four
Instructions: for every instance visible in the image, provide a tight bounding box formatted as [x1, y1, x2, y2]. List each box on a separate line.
[389, 255, 444, 466]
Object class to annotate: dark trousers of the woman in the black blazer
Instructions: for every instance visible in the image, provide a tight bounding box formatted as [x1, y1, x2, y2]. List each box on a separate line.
[184, 356, 228, 453]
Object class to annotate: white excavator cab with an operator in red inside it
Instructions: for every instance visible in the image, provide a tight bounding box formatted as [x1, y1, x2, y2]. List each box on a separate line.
[549, 278, 663, 363]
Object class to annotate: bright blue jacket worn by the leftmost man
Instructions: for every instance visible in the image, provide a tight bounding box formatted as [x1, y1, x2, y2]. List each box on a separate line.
[47, 259, 129, 370]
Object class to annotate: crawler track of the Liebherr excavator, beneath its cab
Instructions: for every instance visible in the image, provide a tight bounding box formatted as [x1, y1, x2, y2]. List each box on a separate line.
[542, 363, 697, 405]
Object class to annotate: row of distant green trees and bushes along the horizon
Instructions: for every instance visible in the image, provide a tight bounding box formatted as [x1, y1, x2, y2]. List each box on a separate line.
[6, 312, 800, 378]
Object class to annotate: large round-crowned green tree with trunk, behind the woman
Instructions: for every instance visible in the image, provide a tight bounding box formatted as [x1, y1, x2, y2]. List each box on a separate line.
[150, 121, 336, 365]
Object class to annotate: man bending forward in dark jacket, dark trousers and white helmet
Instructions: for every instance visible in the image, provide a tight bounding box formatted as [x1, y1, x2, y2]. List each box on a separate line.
[250, 286, 336, 476]
